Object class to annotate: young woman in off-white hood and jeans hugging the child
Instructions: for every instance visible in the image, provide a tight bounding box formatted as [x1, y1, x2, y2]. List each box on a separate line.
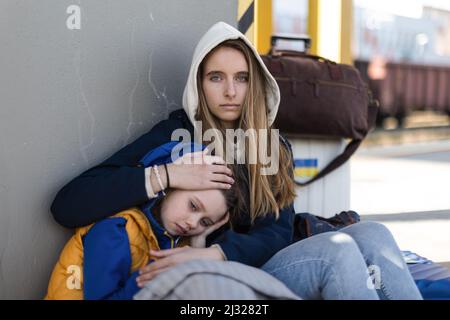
[51, 22, 420, 299]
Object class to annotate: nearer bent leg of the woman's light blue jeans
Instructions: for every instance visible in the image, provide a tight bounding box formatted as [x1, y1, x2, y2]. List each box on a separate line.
[261, 232, 377, 299]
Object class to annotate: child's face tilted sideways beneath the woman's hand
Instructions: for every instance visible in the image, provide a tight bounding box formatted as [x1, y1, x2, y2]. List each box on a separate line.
[159, 187, 236, 236]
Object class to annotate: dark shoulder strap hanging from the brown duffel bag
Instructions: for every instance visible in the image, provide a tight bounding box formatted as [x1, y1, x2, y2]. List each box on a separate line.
[295, 94, 379, 187]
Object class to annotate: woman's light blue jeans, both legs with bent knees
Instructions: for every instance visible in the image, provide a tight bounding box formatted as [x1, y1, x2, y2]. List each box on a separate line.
[262, 222, 422, 300]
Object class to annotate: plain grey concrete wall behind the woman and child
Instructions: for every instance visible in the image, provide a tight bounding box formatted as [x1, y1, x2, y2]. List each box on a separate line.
[0, 0, 237, 299]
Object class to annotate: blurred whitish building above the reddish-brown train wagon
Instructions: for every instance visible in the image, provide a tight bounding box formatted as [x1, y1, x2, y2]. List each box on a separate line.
[353, 6, 450, 65]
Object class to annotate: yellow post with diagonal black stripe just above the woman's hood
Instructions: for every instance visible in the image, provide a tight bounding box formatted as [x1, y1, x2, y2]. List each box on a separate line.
[237, 0, 272, 54]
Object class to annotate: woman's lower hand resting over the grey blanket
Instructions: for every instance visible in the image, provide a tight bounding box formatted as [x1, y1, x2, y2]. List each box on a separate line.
[136, 246, 223, 288]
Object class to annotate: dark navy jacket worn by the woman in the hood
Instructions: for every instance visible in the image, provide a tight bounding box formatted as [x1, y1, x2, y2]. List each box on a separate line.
[51, 109, 295, 267]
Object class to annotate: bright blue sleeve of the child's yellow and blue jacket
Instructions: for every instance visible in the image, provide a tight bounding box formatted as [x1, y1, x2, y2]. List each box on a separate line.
[83, 217, 140, 300]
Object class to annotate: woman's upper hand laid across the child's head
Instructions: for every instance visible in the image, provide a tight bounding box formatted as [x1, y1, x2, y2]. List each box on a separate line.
[167, 149, 234, 190]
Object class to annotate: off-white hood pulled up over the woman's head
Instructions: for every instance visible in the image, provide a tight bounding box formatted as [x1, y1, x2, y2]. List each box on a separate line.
[183, 22, 280, 126]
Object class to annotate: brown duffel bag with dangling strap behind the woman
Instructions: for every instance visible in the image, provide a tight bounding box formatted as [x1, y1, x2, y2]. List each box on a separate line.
[262, 41, 378, 186]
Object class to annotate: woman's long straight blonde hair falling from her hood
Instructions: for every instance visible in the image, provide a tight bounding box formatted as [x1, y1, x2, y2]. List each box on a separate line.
[196, 39, 296, 222]
